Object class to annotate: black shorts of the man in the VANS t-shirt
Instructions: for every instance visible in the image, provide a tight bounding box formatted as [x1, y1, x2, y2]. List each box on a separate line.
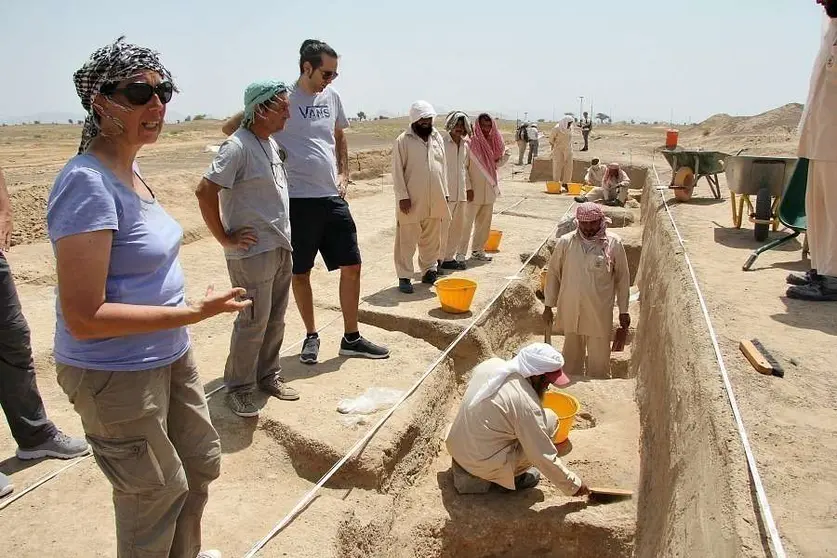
[291, 196, 360, 275]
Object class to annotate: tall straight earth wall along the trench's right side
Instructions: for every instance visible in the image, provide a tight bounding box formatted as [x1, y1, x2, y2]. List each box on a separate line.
[631, 179, 765, 557]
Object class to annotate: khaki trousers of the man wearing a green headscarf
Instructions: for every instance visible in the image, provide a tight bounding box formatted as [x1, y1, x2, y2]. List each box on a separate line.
[224, 248, 293, 393]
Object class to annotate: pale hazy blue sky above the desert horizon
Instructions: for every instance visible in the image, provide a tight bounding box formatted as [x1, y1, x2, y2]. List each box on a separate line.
[0, 0, 822, 122]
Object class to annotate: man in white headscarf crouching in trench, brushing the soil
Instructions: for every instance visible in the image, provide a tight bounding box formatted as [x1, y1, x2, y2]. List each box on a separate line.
[445, 343, 589, 496]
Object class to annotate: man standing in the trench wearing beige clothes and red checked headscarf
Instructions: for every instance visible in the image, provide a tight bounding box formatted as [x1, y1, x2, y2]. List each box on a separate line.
[543, 206, 631, 378]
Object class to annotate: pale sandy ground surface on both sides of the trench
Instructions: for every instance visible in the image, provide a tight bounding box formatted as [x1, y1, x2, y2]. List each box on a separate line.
[0, 104, 837, 556]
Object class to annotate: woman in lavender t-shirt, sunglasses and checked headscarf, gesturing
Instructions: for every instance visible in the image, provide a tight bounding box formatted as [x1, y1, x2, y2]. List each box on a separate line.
[47, 38, 248, 558]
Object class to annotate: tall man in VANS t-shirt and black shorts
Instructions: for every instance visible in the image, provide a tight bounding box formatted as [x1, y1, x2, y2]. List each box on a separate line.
[223, 39, 389, 364]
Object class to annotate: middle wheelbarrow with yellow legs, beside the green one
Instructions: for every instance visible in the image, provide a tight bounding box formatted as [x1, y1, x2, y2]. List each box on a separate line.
[726, 155, 797, 242]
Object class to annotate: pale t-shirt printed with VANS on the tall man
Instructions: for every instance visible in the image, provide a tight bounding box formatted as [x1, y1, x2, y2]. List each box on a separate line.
[273, 85, 349, 198]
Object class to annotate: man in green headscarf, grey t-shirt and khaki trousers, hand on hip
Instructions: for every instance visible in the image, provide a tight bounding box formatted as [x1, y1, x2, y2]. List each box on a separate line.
[196, 81, 299, 417]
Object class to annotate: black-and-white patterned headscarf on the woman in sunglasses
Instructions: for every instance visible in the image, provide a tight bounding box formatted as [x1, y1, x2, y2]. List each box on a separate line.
[73, 36, 177, 153]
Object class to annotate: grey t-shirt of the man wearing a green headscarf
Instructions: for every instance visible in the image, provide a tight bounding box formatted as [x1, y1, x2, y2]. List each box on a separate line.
[204, 128, 291, 260]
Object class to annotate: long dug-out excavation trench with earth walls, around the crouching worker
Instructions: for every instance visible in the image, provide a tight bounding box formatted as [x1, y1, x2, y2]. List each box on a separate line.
[256, 168, 764, 558]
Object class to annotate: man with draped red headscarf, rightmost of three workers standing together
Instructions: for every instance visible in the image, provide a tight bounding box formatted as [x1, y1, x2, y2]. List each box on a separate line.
[463, 113, 511, 262]
